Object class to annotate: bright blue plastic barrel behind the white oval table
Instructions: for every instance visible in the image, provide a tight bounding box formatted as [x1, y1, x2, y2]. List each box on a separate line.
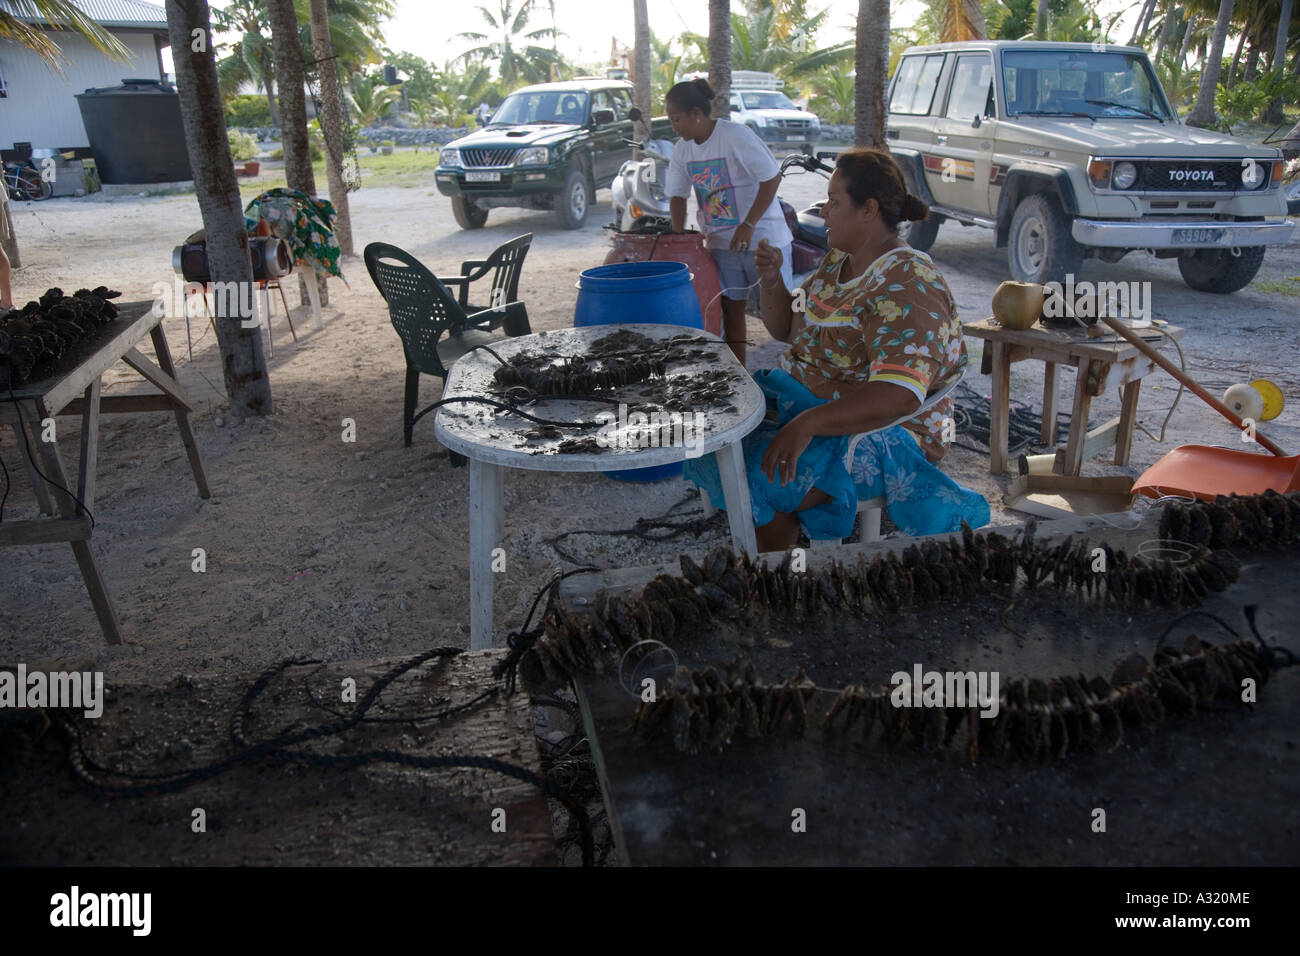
[573, 260, 705, 481]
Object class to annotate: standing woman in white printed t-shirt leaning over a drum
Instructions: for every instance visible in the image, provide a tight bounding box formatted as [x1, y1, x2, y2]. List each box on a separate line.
[664, 79, 794, 364]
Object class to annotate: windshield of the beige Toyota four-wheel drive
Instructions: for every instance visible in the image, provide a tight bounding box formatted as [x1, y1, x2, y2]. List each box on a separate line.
[1002, 49, 1173, 120]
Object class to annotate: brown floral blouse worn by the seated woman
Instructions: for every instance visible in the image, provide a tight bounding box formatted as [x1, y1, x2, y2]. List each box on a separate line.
[779, 247, 967, 460]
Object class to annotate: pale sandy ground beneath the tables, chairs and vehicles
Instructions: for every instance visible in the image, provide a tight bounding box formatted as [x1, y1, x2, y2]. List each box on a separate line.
[0, 166, 1300, 687]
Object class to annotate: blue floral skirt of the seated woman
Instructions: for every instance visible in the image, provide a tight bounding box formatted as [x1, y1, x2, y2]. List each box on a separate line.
[684, 369, 989, 540]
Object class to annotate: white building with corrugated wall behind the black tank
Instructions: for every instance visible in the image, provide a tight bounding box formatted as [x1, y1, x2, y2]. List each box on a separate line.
[0, 0, 170, 150]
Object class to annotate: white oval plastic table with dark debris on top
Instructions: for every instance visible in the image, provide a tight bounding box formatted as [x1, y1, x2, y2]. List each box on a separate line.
[434, 325, 767, 650]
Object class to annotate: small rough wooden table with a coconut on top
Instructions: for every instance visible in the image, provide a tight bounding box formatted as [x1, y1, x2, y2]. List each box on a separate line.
[962, 319, 1186, 475]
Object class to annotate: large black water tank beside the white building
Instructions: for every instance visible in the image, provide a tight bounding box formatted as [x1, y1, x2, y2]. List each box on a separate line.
[77, 79, 194, 183]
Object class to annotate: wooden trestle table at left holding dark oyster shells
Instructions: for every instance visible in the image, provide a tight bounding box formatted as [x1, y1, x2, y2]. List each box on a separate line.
[0, 302, 208, 644]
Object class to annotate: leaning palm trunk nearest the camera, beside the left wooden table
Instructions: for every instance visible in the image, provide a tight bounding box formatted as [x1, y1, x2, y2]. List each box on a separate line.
[166, 0, 272, 419]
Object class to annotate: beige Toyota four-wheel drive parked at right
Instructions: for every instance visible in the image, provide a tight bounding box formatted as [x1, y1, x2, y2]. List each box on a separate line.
[885, 40, 1292, 293]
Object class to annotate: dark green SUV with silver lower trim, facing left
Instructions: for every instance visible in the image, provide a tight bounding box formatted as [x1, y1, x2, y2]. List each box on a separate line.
[434, 78, 672, 229]
